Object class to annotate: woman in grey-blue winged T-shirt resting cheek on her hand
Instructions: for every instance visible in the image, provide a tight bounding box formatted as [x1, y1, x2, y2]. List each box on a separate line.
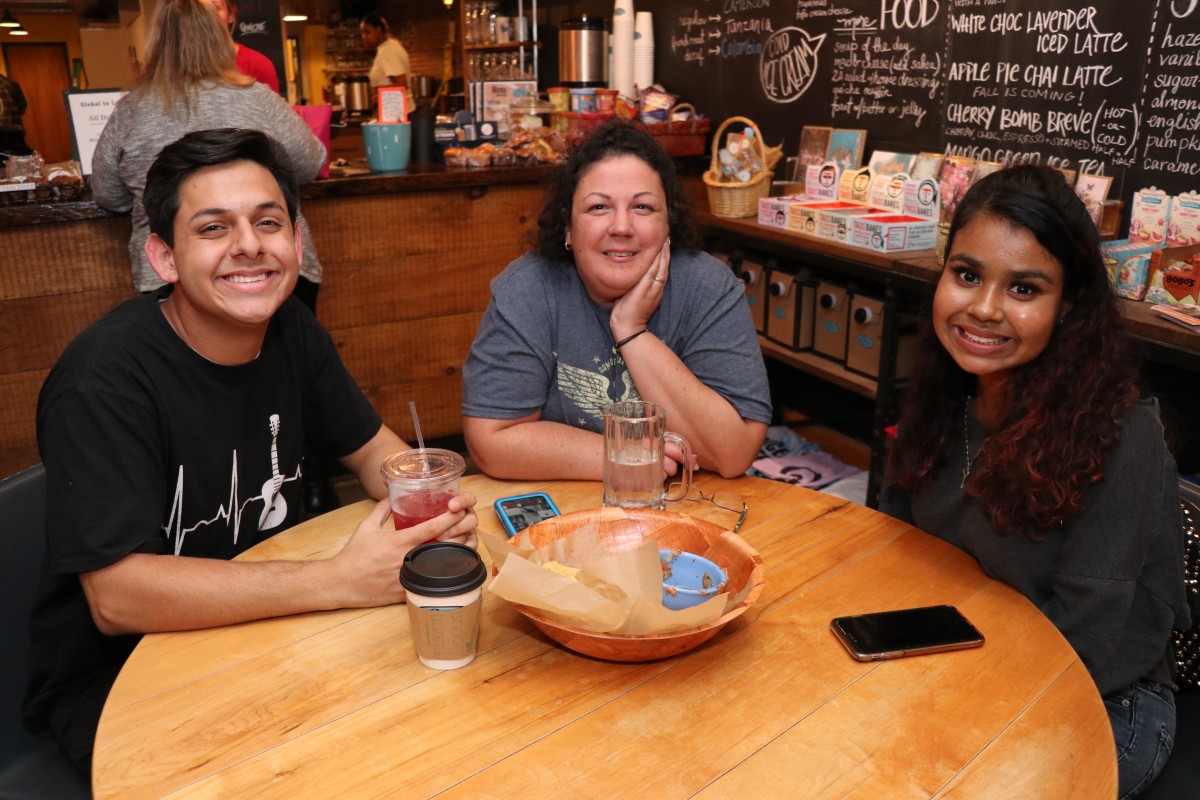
[462, 121, 770, 480]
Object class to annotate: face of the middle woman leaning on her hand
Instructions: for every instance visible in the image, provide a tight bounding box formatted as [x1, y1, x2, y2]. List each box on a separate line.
[566, 155, 670, 306]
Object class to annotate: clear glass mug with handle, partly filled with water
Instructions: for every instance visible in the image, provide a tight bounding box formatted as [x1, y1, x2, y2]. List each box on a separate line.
[604, 401, 691, 509]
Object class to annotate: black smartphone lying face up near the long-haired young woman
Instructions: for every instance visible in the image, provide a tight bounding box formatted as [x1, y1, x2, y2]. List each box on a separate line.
[829, 606, 984, 661]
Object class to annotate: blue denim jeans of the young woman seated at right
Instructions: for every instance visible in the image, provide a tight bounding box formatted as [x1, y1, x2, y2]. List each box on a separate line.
[1104, 680, 1175, 800]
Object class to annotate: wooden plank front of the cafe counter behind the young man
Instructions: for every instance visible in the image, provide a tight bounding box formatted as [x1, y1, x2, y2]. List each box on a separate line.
[0, 166, 551, 475]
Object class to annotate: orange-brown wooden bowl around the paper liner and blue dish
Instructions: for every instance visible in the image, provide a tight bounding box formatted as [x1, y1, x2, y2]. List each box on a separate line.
[512, 509, 766, 661]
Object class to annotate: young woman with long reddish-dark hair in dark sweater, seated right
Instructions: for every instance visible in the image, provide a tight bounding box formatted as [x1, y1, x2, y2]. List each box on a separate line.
[881, 166, 1188, 798]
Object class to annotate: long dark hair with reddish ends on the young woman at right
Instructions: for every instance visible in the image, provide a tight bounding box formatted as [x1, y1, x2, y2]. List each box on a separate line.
[888, 164, 1140, 537]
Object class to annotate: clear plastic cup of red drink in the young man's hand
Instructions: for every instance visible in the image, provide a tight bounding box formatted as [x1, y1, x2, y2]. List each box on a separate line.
[382, 447, 467, 541]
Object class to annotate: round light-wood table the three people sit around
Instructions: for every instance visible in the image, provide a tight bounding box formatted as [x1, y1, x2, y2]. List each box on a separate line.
[92, 474, 1116, 800]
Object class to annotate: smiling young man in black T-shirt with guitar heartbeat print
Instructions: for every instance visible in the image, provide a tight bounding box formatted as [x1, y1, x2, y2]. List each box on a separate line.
[24, 128, 476, 777]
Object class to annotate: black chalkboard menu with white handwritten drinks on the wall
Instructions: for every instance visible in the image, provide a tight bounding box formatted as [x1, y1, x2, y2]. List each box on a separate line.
[619, 0, 1200, 199]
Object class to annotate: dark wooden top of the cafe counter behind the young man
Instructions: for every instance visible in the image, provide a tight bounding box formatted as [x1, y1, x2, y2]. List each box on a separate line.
[0, 164, 553, 228]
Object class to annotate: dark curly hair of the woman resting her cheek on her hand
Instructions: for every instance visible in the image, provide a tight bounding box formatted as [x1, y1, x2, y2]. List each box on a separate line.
[538, 119, 700, 261]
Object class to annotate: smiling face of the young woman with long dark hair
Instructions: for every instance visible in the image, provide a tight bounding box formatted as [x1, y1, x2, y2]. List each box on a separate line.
[934, 215, 1064, 389]
